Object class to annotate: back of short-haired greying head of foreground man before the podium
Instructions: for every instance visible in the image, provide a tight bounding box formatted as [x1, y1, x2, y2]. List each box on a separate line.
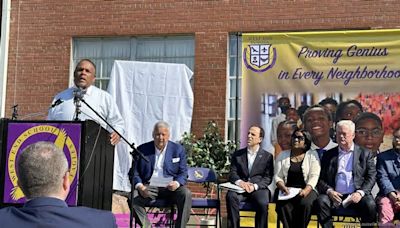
[17, 142, 68, 199]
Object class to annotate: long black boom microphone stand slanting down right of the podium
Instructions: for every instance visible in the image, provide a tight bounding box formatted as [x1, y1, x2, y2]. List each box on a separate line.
[77, 96, 149, 228]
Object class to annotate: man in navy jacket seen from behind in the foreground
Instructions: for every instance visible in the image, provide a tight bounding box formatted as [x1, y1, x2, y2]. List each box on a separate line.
[0, 142, 117, 228]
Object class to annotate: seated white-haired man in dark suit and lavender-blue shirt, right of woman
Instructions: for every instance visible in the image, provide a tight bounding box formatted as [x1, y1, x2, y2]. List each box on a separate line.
[316, 120, 376, 227]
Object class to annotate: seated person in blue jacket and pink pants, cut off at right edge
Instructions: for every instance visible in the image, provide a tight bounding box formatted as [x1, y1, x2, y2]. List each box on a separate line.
[376, 128, 400, 227]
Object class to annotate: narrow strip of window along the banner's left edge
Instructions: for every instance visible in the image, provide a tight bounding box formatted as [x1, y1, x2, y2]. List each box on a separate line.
[226, 35, 242, 142]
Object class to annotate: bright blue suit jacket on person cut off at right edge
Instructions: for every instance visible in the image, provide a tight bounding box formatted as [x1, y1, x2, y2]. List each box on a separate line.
[376, 149, 400, 196]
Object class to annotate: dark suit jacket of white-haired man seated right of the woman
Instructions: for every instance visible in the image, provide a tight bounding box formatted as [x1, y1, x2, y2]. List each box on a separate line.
[317, 144, 376, 195]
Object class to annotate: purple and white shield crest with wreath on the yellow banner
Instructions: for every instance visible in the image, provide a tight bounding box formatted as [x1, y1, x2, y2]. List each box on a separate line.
[243, 44, 276, 73]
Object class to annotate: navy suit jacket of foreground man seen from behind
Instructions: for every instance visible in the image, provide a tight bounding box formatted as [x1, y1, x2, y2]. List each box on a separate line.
[0, 197, 117, 228]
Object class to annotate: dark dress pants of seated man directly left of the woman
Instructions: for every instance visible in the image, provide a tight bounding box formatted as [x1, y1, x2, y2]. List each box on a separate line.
[226, 189, 270, 228]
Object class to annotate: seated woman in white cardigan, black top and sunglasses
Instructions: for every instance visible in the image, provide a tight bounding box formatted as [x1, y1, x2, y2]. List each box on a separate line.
[274, 129, 321, 228]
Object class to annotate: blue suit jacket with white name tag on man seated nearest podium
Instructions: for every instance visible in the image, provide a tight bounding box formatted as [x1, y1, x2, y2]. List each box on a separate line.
[133, 141, 188, 186]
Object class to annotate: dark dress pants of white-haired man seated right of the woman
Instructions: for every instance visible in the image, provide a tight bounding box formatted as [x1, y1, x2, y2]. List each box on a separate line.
[315, 194, 376, 228]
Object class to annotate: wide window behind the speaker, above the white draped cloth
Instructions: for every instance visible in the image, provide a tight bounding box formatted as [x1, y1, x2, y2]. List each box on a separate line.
[73, 36, 194, 90]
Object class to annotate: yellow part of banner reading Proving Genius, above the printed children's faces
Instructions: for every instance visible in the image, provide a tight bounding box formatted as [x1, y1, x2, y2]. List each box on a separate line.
[241, 30, 400, 149]
